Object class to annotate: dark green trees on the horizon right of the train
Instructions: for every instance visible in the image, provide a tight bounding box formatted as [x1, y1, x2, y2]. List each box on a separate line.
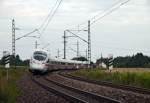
[97, 53, 150, 68]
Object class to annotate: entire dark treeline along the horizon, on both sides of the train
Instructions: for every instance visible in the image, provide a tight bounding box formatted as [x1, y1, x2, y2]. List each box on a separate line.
[0, 53, 150, 68]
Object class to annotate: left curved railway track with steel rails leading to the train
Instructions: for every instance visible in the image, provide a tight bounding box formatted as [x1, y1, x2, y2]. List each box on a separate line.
[31, 73, 121, 103]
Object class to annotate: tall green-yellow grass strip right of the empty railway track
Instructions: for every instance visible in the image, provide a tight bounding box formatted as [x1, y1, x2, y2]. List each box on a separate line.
[71, 69, 150, 89]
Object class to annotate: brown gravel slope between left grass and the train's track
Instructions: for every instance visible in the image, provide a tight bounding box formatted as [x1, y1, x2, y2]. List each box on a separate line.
[18, 74, 68, 103]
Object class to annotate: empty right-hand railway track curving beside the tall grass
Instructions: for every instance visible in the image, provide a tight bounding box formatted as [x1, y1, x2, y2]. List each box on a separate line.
[59, 72, 150, 95]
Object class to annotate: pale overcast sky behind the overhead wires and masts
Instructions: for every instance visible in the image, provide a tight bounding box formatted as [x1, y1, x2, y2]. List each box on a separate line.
[0, 0, 150, 60]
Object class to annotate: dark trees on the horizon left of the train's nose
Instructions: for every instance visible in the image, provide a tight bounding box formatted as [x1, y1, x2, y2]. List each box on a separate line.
[0, 55, 29, 66]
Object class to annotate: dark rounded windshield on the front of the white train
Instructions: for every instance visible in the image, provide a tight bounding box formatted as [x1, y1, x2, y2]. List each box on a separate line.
[33, 51, 47, 61]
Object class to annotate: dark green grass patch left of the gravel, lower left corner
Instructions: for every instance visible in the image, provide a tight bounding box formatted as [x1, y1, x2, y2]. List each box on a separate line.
[0, 67, 26, 103]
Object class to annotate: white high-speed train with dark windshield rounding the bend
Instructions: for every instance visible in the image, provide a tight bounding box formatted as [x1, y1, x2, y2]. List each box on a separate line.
[29, 49, 87, 72]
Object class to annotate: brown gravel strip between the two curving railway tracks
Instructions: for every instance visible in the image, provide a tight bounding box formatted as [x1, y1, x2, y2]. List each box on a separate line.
[48, 74, 150, 103]
